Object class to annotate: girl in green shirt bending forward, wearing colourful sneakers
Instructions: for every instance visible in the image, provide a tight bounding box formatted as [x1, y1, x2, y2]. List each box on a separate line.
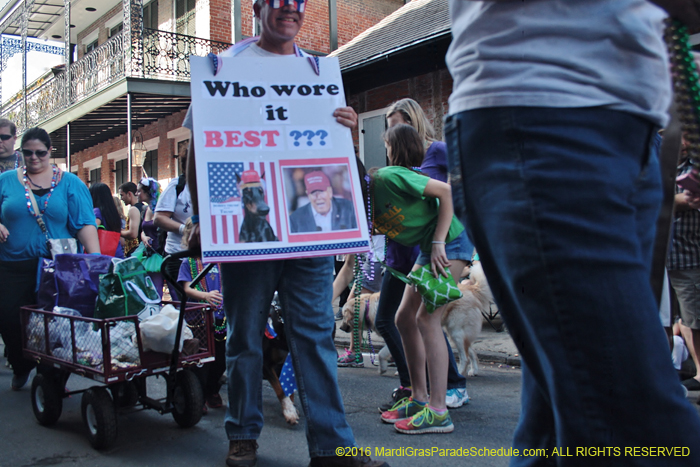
[370, 125, 472, 434]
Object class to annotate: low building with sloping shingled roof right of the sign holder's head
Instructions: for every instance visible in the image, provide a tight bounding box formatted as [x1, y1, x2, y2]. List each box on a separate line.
[330, 0, 452, 168]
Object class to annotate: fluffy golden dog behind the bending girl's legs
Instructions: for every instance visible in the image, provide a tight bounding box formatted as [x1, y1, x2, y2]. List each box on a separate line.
[340, 262, 493, 376]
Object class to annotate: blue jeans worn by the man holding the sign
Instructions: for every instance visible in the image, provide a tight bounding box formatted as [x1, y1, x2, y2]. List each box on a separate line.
[221, 257, 355, 457]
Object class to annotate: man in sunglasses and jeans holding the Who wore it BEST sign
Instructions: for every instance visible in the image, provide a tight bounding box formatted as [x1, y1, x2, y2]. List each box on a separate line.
[183, 0, 387, 467]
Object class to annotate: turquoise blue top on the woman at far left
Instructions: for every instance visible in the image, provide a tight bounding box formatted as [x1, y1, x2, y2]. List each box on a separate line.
[0, 170, 95, 261]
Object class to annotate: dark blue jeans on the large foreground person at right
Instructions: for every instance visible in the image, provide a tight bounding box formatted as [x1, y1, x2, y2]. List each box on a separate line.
[446, 108, 700, 466]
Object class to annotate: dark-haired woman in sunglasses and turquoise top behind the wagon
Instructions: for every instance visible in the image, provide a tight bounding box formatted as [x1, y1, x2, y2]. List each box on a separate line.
[0, 128, 100, 391]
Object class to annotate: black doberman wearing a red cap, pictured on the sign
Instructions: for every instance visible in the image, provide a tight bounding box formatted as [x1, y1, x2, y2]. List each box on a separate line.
[236, 170, 278, 243]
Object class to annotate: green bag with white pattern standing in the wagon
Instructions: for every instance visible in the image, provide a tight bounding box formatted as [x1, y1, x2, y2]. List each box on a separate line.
[95, 257, 160, 319]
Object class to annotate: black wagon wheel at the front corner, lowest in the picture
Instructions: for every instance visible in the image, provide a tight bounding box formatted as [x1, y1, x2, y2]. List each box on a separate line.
[80, 387, 117, 449]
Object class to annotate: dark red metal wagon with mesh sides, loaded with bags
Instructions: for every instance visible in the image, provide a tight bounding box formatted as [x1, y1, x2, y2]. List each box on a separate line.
[21, 254, 214, 449]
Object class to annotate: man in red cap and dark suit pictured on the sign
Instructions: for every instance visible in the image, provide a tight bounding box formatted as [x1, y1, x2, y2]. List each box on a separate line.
[289, 170, 357, 233]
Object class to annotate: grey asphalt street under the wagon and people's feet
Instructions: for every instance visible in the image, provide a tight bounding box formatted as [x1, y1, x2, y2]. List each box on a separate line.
[0, 322, 520, 467]
